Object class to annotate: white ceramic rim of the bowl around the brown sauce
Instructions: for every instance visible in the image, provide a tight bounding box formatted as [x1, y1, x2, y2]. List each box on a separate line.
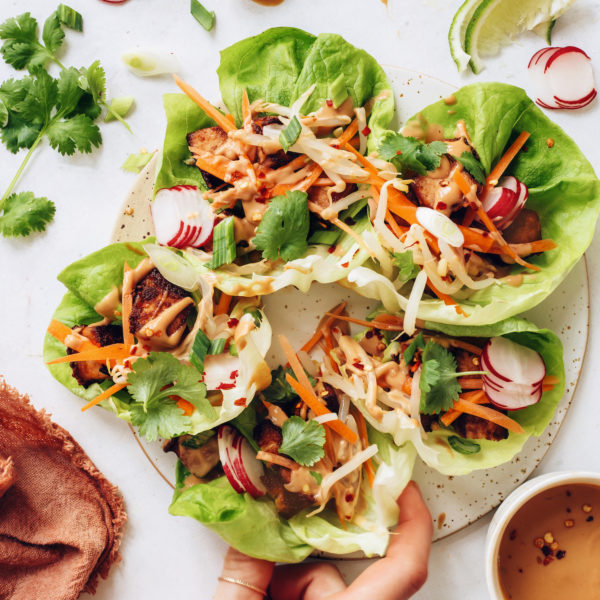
[485, 471, 600, 600]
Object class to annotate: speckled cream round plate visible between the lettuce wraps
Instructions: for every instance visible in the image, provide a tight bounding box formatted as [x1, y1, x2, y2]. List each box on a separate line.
[111, 65, 590, 544]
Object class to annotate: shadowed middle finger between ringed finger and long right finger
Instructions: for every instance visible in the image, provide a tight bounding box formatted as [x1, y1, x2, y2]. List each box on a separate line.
[269, 563, 346, 600]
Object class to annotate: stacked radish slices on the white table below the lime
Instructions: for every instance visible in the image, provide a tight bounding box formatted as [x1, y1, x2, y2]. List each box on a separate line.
[528, 46, 597, 110]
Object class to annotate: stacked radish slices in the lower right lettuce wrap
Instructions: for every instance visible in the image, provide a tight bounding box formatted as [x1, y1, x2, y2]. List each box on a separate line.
[481, 337, 546, 410]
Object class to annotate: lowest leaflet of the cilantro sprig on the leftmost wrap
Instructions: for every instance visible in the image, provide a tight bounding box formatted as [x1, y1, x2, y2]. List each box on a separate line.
[130, 398, 191, 442]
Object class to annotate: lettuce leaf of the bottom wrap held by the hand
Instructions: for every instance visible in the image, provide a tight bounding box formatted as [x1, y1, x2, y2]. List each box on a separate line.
[169, 418, 416, 563]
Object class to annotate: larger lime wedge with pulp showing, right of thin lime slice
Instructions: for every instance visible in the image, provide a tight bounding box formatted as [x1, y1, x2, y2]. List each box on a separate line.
[464, 0, 574, 73]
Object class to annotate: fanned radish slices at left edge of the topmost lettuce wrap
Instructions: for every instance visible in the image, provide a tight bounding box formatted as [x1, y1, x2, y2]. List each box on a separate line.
[150, 185, 214, 248]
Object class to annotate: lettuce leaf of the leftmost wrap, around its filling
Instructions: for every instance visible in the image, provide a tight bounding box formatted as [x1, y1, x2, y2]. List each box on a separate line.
[44, 239, 271, 439]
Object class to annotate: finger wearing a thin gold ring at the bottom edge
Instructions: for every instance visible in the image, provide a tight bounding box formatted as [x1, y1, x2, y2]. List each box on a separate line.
[215, 548, 274, 600]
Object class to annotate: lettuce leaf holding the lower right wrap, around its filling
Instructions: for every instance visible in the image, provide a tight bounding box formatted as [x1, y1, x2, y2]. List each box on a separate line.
[340, 317, 565, 475]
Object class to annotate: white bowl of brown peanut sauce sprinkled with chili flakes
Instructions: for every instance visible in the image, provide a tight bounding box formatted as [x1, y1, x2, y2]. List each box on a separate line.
[486, 471, 600, 600]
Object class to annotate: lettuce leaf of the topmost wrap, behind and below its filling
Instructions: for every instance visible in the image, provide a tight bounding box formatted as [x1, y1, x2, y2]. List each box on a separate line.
[154, 27, 394, 296]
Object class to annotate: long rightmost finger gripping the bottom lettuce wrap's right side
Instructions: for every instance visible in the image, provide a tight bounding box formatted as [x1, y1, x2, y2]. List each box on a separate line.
[332, 482, 433, 600]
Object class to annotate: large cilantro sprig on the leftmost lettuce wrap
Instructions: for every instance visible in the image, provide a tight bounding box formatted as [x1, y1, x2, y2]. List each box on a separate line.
[127, 352, 216, 441]
